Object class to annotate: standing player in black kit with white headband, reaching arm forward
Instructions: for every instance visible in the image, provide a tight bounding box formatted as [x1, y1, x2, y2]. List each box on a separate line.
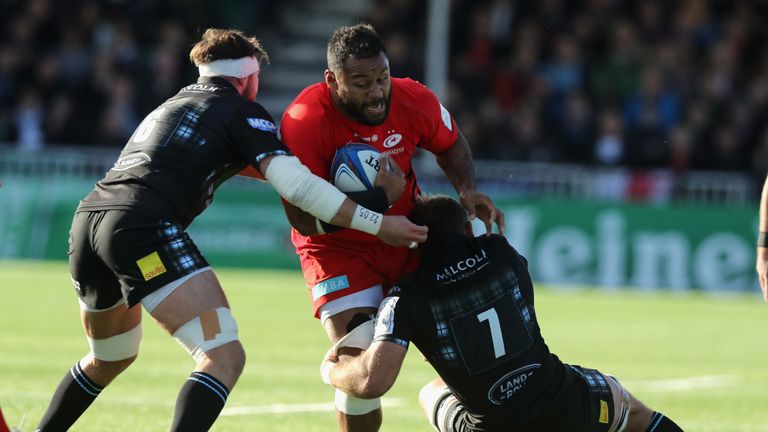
[38, 29, 426, 431]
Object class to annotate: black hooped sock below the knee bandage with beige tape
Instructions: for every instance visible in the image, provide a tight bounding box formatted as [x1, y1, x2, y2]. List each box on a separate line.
[171, 372, 229, 431]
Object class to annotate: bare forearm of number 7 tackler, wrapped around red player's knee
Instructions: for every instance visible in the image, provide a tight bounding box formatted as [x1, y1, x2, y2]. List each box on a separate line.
[320, 341, 408, 399]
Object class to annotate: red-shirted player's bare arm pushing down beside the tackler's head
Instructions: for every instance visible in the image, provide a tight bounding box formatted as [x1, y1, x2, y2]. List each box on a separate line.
[435, 130, 504, 235]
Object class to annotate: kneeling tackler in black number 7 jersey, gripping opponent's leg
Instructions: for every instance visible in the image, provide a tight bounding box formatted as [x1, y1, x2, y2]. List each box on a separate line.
[321, 196, 681, 432]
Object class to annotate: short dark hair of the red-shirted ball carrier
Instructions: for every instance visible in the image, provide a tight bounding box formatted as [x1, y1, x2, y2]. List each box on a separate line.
[327, 23, 387, 72]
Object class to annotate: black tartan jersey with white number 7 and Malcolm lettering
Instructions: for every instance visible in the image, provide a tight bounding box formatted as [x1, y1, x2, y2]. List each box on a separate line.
[374, 234, 570, 430]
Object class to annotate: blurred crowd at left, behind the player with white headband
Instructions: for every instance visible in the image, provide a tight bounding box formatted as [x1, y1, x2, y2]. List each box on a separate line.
[0, 0, 274, 150]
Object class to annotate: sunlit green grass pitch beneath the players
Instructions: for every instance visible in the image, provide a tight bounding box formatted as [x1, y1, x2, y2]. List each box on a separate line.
[0, 262, 768, 432]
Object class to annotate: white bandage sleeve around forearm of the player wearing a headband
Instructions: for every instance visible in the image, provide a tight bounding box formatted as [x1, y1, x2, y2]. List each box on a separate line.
[264, 155, 347, 223]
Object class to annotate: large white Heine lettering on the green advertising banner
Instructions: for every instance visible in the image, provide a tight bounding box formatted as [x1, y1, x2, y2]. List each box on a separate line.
[505, 207, 759, 292]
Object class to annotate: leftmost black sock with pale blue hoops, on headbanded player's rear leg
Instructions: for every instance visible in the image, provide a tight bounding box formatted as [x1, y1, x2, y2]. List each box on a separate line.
[36, 362, 102, 432]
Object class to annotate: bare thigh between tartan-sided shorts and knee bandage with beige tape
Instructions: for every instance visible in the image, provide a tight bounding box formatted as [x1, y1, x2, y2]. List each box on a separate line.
[150, 270, 229, 334]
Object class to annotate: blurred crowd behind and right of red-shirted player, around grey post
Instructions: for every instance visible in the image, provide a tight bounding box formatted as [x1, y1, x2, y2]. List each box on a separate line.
[368, 0, 768, 178]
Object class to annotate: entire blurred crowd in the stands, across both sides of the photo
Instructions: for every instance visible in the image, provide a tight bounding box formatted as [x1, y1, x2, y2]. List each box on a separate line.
[0, 0, 768, 177]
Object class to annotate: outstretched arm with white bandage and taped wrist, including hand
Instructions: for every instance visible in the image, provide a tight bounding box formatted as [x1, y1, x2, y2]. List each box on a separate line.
[259, 155, 427, 246]
